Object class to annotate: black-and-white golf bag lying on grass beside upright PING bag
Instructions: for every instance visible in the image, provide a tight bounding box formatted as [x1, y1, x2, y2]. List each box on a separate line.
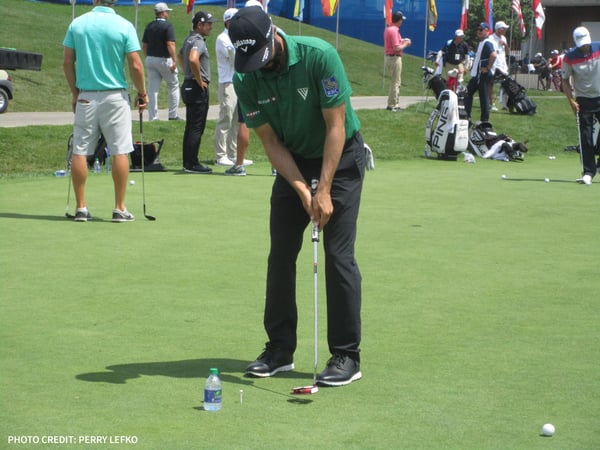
[469, 122, 528, 162]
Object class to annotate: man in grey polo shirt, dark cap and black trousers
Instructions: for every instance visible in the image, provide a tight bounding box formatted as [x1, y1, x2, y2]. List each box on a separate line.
[178, 11, 215, 174]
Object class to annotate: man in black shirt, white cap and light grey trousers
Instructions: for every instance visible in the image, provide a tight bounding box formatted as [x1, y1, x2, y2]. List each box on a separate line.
[142, 2, 181, 120]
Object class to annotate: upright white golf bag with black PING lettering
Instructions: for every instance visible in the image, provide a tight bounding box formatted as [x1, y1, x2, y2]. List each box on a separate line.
[425, 89, 469, 161]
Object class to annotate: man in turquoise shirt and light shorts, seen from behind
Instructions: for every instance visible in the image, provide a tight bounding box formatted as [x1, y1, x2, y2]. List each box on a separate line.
[63, 0, 148, 222]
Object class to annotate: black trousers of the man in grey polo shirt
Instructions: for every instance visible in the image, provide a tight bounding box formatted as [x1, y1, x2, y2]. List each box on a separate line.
[181, 80, 208, 169]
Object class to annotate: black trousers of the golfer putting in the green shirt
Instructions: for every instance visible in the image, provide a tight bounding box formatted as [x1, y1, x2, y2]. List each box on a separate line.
[264, 133, 365, 360]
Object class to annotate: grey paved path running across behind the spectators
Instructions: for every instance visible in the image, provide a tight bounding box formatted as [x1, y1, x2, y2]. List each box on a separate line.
[0, 96, 424, 128]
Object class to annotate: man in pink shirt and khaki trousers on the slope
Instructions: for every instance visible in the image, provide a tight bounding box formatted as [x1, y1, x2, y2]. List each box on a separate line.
[383, 11, 411, 112]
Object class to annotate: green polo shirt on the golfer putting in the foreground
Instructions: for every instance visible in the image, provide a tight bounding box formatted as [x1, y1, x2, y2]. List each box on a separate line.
[233, 35, 360, 159]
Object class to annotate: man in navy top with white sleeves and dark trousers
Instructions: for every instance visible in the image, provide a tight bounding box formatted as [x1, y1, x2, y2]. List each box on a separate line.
[465, 22, 496, 122]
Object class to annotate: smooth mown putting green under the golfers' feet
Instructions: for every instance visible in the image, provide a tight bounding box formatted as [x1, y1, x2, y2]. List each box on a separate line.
[0, 153, 600, 449]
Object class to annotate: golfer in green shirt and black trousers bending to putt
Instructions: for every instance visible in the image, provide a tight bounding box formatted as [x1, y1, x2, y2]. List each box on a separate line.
[229, 7, 365, 386]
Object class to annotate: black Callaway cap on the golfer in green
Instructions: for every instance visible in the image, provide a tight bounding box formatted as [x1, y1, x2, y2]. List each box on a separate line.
[229, 6, 274, 73]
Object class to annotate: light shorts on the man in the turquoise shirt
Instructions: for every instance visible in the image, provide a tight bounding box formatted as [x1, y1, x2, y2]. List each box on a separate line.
[73, 90, 133, 155]
